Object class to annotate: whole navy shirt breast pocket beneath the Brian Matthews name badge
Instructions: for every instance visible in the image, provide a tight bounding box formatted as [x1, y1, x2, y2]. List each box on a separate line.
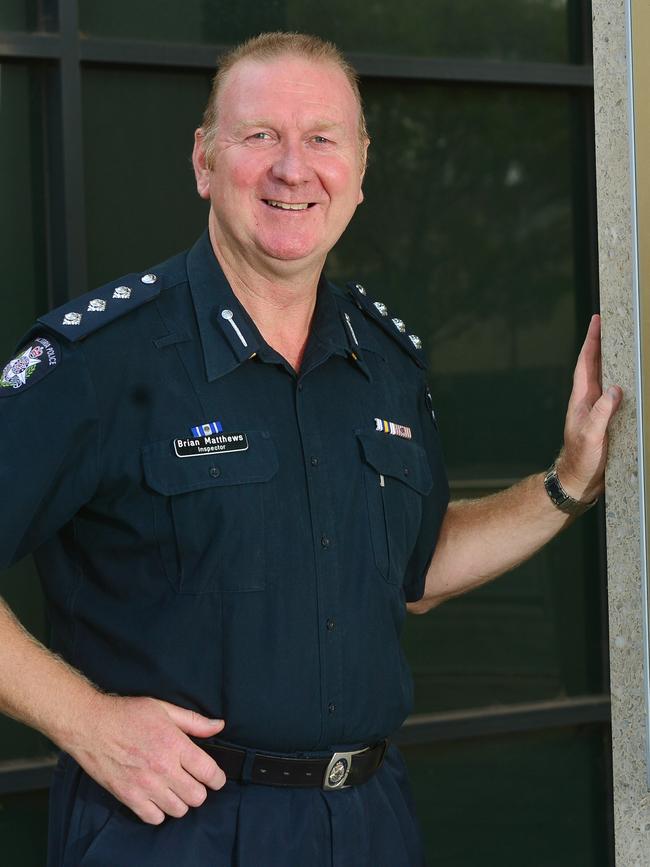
[142, 431, 278, 594]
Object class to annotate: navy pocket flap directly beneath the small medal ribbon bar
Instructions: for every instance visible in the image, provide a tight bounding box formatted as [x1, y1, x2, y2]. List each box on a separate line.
[357, 432, 433, 496]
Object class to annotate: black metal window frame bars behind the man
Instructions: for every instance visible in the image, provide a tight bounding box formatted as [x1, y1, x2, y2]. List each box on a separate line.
[0, 6, 613, 863]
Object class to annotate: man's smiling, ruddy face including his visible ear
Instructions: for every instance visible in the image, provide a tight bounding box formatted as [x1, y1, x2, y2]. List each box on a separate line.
[194, 56, 363, 272]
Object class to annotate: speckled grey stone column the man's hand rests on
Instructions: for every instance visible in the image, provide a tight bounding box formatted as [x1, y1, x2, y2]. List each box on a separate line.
[593, 0, 650, 867]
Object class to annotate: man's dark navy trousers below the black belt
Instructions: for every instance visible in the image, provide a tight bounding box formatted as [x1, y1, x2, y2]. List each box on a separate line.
[48, 746, 425, 867]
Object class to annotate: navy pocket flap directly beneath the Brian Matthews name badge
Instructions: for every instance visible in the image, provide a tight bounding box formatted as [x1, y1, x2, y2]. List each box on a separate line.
[142, 431, 278, 496]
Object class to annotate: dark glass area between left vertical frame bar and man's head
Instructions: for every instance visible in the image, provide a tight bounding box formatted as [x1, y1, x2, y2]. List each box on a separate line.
[83, 70, 210, 286]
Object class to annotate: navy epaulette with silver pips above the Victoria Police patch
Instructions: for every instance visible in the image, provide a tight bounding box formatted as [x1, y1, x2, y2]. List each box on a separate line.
[38, 273, 163, 342]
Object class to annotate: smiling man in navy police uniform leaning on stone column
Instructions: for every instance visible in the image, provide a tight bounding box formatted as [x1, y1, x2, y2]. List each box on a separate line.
[0, 34, 621, 867]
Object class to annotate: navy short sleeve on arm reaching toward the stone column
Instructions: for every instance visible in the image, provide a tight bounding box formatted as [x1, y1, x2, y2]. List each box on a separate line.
[403, 379, 449, 602]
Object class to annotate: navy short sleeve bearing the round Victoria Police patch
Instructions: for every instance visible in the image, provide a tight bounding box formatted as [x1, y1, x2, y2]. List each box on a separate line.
[0, 328, 99, 569]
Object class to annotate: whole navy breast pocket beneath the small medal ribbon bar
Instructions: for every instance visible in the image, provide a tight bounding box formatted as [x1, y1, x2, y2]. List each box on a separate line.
[357, 432, 433, 585]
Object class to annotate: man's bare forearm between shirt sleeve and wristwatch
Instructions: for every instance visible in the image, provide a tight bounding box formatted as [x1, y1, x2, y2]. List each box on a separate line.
[408, 473, 572, 614]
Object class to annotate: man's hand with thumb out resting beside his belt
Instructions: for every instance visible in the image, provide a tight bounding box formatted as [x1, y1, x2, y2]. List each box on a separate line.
[64, 693, 226, 825]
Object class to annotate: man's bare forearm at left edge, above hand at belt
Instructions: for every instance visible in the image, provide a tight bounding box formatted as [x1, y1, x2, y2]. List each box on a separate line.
[0, 598, 99, 749]
